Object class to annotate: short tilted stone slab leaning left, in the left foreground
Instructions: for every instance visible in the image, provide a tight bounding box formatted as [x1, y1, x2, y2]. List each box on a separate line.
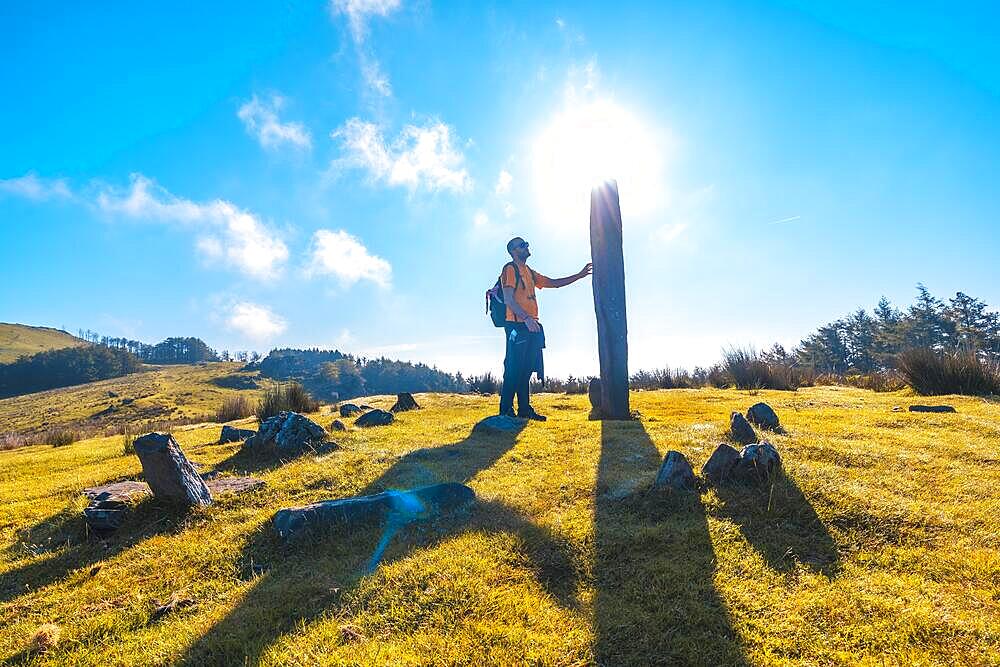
[135, 433, 212, 505]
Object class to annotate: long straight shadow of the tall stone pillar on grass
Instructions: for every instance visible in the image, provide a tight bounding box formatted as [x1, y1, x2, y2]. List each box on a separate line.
[594, 421, 747, 665]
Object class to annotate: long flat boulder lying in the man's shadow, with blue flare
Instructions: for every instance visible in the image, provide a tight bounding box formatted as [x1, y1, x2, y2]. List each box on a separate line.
[274, 482, 476, 539]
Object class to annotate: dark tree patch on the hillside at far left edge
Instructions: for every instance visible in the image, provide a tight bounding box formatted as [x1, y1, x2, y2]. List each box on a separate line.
[0, 345, 141, 398]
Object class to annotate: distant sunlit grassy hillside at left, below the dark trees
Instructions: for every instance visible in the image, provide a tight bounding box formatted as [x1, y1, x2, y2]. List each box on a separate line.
[0, 362, 259, 434]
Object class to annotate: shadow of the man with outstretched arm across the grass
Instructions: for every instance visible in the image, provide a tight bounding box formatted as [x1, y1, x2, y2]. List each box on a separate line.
[181, 422, 578, 665]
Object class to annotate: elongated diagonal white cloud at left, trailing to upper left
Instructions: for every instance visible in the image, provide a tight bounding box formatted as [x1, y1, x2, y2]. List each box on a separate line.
[97, 174, 288, 279]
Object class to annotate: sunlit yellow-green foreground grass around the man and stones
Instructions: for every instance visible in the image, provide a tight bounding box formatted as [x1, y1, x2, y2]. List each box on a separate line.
[0, 387, 1000, 665]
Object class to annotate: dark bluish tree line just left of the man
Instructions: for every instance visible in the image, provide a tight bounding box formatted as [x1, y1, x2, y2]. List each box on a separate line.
[258, 348, 469, 400]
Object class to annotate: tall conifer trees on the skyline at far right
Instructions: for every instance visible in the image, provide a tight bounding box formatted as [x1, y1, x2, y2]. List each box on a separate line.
[788, 285, 1000, 375]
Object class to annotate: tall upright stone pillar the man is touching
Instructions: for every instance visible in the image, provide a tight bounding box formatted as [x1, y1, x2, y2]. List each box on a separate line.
[590, 181, 632, 419]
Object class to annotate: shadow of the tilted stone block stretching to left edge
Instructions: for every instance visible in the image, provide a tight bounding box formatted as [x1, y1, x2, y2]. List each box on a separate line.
[0, 498, 195, 603]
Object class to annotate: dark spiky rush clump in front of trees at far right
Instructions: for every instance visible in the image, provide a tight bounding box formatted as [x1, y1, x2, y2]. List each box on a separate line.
[896, 347, 1000, 396]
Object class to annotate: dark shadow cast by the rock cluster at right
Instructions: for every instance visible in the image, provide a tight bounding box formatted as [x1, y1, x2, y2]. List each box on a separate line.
[715, 471, 841, 577]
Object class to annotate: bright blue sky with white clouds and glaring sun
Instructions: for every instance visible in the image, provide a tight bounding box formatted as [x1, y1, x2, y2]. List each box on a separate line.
[0, 0, 1000, 375]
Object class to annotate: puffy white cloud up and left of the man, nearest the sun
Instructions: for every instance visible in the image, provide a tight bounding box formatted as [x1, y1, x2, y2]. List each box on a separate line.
[330, 118, 472, 192]
